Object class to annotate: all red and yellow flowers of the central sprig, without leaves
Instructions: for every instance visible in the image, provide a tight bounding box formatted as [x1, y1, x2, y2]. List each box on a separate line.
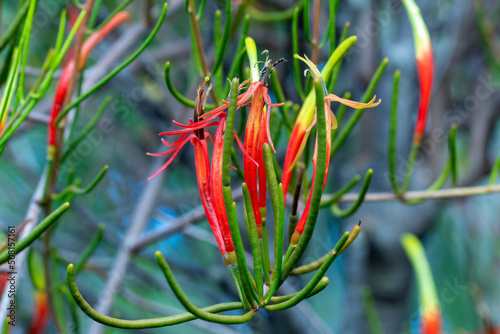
[149, 52, 378, 264]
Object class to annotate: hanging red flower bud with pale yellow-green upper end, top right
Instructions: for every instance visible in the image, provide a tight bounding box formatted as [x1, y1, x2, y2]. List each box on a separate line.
[403, 0, 434, 145]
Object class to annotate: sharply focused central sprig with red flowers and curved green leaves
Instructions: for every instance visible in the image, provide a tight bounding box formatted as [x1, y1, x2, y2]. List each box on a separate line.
[67, 37, 380, 328]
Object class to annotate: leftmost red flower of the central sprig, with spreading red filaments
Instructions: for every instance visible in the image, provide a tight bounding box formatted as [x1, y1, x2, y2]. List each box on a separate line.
[148, 86, 235, 265]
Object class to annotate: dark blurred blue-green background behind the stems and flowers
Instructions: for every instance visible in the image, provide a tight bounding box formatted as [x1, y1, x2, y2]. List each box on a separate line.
[0, 0, 500, 334]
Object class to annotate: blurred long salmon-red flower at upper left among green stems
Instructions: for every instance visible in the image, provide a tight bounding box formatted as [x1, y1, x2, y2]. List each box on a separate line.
[47, 12, 130, 149]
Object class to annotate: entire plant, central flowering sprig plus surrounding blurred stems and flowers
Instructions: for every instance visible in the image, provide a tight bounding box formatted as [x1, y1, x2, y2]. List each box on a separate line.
[0, 0, 500, 333]
